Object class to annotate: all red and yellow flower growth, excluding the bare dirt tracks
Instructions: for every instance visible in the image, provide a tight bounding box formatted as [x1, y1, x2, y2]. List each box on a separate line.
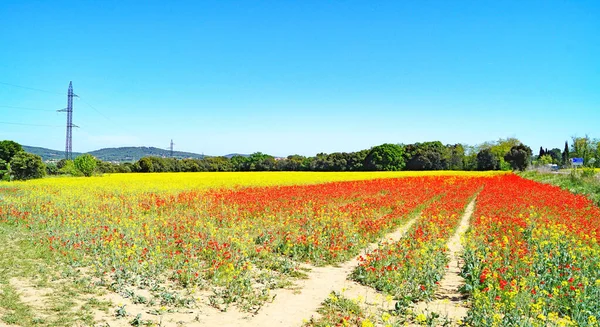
[0, 172, 600, 326]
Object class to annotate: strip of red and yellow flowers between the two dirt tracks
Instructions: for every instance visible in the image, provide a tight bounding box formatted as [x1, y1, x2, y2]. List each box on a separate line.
[353, 178, 484, 305]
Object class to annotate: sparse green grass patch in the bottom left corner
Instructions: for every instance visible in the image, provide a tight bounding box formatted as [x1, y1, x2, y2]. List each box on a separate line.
[0, 225, 101, 327]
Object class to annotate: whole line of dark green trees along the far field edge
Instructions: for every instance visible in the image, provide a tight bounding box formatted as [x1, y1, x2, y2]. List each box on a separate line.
[0, 136, 600, 180]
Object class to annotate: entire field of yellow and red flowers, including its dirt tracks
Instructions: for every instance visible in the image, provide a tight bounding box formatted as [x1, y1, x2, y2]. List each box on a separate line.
[0, 172, 600, 327]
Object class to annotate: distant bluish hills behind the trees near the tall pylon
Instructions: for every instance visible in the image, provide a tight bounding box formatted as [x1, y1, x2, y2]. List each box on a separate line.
[23, 145, 205, 162]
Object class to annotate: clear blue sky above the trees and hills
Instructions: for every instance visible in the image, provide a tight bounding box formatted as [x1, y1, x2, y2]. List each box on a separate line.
[0, 0, 600, 155]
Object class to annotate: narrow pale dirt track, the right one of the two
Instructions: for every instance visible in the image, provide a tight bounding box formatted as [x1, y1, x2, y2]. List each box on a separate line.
[415, 199, 475, 325]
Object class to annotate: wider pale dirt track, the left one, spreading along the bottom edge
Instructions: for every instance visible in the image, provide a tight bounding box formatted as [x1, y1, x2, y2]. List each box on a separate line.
[0, 218, 417, 327]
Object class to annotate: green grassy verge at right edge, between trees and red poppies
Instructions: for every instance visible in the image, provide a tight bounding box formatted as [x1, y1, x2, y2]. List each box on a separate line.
[520, 169, 600, 205]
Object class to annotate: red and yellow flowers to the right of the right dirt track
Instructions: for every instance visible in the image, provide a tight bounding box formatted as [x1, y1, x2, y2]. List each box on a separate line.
[464, 176, 600, 326]
